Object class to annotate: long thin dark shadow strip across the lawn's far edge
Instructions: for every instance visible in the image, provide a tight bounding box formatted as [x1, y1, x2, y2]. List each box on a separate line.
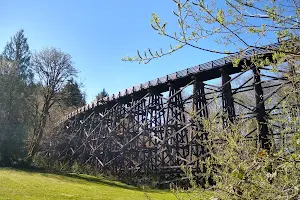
[6, 168, 167, 193]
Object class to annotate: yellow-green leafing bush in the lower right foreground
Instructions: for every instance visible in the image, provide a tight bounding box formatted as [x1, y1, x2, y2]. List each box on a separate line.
[180, 96, 300, 200]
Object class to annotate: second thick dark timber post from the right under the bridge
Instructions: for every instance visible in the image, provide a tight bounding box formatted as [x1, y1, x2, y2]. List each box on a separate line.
[220, 69, 235, 126]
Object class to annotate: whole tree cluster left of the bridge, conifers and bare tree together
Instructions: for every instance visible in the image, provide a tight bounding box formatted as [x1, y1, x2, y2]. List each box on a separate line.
[0, 30, 85, 166]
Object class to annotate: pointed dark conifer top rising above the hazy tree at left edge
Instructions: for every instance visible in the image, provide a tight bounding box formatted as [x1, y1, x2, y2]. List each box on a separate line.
[2, 29, 33, 83]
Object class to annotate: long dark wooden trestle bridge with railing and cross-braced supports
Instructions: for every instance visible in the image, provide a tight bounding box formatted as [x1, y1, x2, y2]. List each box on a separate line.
[43, 44, 298, 186]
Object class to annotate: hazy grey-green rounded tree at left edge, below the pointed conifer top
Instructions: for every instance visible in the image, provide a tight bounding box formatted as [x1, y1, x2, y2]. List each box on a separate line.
[0, 58, 30, 166]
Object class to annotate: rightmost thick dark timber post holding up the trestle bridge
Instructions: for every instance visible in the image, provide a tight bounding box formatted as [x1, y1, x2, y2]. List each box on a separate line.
[252, 66, 270, 150]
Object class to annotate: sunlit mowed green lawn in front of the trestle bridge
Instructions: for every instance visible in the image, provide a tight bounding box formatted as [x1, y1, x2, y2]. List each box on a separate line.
[0, 168, 183, 200]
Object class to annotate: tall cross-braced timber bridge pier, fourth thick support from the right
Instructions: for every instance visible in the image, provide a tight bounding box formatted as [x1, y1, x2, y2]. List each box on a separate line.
[161, 84, 189, 178]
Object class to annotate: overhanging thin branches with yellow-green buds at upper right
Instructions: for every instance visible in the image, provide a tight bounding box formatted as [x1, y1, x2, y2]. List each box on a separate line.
[123, 0, 300, 63]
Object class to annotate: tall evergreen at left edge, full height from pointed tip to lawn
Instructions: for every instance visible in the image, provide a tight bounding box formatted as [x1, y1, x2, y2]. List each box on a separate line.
[0, 30, 33, 166]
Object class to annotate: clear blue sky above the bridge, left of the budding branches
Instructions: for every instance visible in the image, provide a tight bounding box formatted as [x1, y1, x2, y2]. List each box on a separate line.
[0, 0, 232, 102]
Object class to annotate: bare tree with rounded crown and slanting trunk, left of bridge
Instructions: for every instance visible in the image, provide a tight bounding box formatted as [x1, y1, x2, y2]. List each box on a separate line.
[28, 48, 77, 160]
